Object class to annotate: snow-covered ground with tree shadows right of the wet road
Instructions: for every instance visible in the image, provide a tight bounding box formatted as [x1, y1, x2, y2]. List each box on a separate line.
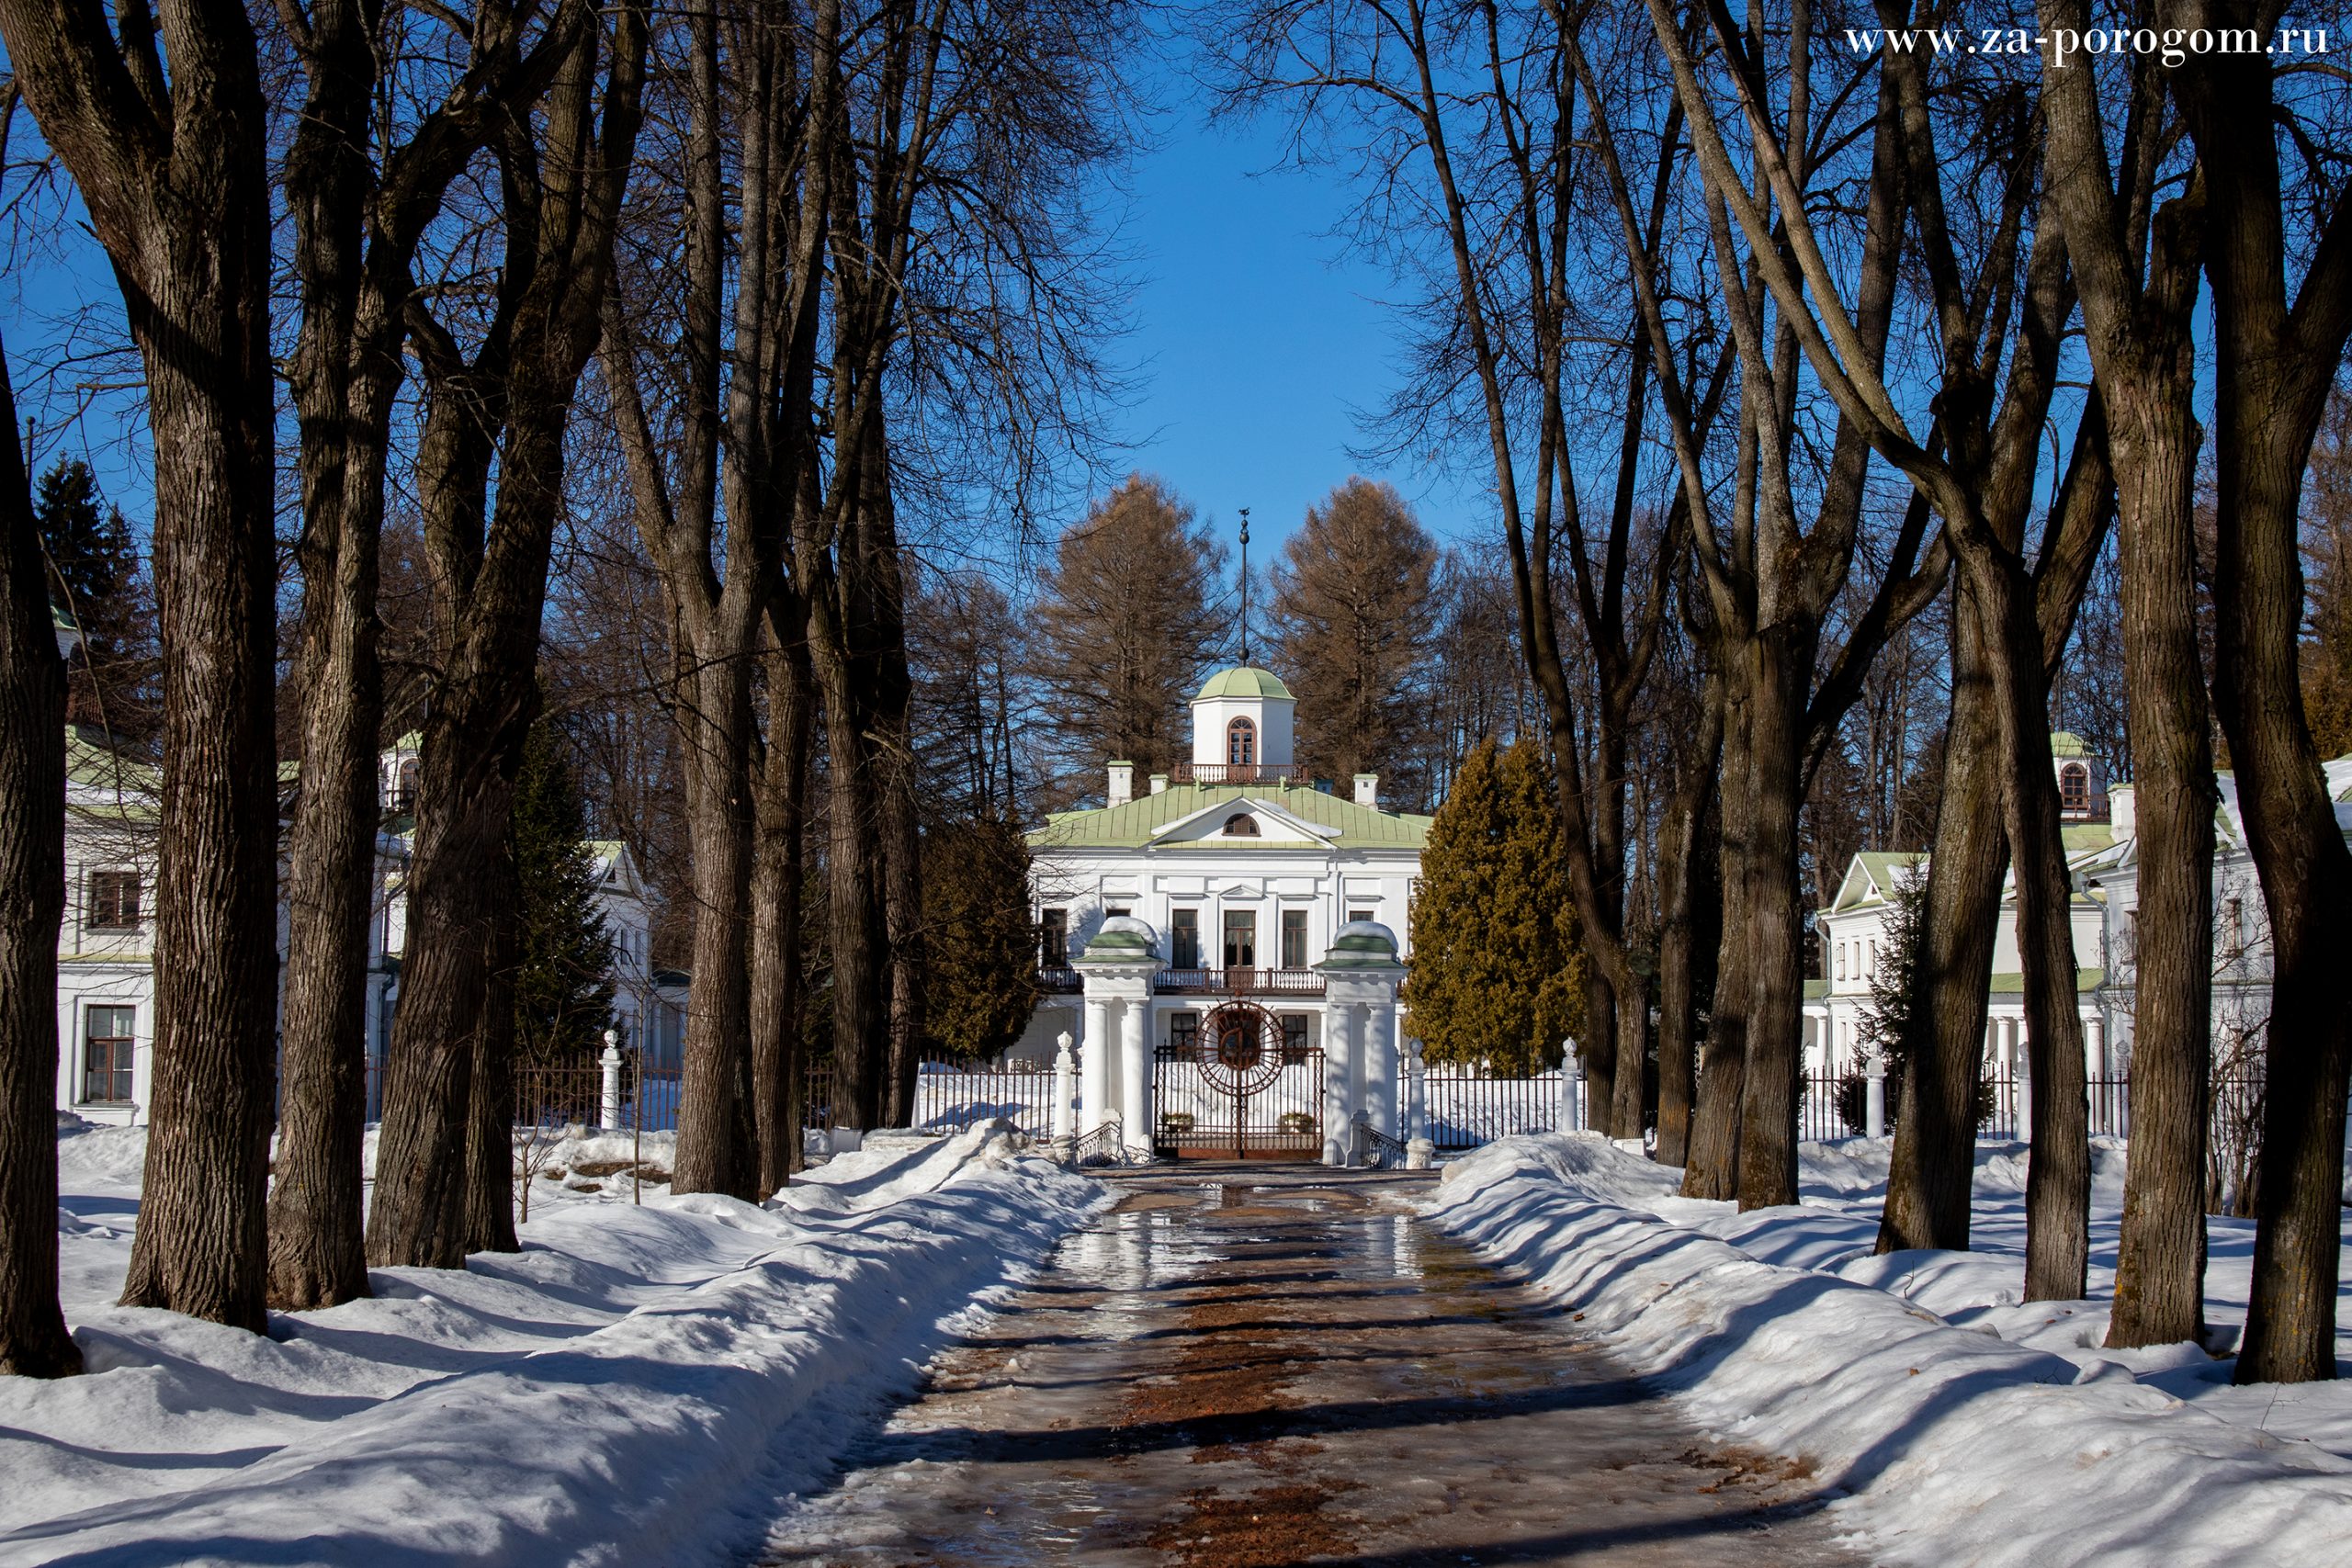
[1430, 1135, 2352, 1568]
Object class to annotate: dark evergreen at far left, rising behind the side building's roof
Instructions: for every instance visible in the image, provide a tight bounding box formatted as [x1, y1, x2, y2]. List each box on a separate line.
[33, 458, 160, 740]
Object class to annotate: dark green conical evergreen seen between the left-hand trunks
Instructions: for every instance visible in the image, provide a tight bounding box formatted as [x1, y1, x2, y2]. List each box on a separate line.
[508, 724, 614, 1063]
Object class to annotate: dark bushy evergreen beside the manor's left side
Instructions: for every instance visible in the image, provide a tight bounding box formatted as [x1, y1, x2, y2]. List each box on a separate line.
[922, 816, 1037, 1060]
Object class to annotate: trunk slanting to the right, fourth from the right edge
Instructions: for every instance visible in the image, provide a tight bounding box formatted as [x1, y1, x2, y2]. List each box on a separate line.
[1877, 594, 2008, 1253]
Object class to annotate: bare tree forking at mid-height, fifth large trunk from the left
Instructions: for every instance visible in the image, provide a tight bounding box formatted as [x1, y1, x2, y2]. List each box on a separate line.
[602, 0, 840, 1197]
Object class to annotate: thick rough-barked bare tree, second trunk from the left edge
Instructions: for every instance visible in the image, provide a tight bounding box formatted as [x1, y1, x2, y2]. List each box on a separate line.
[0, 0, 277, 1331]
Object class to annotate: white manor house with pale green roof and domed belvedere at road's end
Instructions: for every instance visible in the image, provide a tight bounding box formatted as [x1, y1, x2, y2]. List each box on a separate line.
[1012, 665, 1430, 1155]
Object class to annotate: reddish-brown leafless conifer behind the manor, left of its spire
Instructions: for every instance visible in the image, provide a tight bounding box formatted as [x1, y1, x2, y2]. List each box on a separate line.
[1035, 475, 1227, 790]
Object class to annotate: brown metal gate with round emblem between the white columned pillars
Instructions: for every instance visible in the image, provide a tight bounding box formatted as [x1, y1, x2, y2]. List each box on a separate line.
[1152, 1001, 1322, 1159]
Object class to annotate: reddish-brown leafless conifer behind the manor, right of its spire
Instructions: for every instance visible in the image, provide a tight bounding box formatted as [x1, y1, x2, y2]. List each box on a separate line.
[1272, 478, 1437, 802]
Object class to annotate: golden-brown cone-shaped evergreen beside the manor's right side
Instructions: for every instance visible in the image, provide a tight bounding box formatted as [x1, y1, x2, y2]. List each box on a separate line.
[1404, 740, 1585, 1075]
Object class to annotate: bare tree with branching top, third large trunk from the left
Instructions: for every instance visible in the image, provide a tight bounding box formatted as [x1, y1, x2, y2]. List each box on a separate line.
[270, 0, 579, 1309]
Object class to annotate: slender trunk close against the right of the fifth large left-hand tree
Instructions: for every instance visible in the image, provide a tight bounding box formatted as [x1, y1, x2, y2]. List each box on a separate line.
[751, 616, 816, 1194]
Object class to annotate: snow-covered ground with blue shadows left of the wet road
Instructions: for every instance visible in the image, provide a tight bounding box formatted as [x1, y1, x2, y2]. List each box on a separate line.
[0, 1128, 1105, 1565]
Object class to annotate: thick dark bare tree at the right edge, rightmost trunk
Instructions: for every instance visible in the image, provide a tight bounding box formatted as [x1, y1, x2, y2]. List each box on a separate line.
[2154, 0, 2352, 1382]
